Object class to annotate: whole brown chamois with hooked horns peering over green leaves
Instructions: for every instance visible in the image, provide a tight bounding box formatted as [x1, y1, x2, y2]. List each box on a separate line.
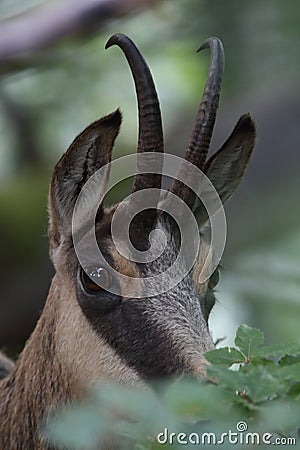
[0, 34, 255, 450]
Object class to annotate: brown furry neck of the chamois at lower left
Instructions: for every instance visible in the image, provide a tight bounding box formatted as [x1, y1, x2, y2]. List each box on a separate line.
[0, 282, 74, 450]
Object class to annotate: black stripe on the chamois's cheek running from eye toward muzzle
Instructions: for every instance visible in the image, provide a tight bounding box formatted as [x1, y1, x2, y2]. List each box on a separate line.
[79, 293, 188, 380]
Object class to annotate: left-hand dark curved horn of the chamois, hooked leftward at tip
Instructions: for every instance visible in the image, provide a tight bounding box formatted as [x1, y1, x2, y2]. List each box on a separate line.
[105, 34, 164, 192]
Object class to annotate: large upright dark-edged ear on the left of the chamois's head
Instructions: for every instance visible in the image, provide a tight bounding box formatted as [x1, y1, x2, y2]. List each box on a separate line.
[49, 110, 121, 245]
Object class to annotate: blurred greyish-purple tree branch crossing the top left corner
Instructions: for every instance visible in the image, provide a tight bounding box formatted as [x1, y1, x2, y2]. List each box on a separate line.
[0, 0, 157, 71]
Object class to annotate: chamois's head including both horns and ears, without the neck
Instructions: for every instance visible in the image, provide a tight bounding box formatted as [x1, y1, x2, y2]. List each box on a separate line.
[49, 34, 255, 382]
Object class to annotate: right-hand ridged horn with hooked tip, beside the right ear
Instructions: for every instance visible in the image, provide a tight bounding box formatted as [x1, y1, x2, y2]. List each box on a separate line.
[171, 37, 224, 207]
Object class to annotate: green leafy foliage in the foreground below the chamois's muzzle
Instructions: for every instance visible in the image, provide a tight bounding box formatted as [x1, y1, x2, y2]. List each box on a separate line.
[45, 325, 300, 450]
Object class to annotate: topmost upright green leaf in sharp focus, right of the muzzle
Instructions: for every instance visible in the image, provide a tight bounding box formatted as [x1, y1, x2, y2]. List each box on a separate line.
[235, 325, 264, 361]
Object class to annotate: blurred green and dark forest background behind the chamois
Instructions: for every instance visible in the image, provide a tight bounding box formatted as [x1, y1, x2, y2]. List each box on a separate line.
[0, 0, 300, 354]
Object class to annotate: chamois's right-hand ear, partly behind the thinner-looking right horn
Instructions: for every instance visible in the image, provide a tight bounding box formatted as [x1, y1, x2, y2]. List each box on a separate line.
[194, 114, 256, 226]
